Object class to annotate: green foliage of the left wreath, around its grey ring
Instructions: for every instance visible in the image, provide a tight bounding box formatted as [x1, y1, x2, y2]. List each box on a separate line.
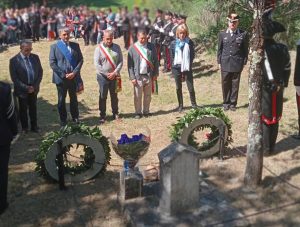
[35, 123, 111, 178]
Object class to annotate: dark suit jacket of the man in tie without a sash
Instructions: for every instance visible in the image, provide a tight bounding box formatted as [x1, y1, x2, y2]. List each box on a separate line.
[9, 53, 43, 98]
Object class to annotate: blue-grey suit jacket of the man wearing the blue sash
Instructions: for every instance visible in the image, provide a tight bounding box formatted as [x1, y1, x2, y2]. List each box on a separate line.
[49, 42, 83, 84]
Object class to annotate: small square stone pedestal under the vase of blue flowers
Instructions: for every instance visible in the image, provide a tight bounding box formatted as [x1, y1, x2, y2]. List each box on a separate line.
[119, 169, 143, 203]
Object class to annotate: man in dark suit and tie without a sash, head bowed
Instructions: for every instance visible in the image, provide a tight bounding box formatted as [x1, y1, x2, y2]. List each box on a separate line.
[9, 41, 43, 133]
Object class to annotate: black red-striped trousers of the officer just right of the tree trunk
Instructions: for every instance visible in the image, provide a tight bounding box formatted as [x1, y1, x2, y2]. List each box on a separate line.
[262, 87, 284, 153]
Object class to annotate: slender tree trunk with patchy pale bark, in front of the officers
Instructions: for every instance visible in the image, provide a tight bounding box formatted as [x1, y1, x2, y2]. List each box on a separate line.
[244, 0, 264, 188]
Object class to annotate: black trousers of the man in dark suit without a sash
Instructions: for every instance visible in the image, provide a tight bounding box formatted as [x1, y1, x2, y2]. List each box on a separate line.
[18, 93, 37, 129]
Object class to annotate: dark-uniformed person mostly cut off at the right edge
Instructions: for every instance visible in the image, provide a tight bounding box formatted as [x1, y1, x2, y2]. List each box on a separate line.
[293, 40, 300, 139]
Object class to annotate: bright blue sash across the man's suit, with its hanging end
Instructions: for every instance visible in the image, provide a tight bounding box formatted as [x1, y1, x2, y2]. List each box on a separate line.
[56, 40, 84, 94]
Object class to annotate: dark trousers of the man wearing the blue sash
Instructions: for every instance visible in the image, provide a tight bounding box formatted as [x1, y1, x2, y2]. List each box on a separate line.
[56, 79, 79, 122]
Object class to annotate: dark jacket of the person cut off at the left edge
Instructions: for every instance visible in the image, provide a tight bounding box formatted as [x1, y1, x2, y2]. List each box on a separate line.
[0, 82, 18, 145]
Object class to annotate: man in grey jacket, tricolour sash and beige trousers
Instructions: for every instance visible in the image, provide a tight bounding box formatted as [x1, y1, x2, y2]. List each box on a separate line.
[127, 30, 159, 119]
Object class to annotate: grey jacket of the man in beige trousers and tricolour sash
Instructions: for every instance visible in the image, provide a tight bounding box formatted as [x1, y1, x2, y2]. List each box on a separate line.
[127, 43, 159, 80]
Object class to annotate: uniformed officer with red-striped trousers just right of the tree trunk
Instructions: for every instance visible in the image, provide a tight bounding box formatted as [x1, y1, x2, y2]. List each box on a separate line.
[262, 19, 291, 155]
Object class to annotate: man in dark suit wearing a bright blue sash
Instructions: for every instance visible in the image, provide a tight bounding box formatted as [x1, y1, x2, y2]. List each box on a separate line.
[49, 28, 83, 126]
